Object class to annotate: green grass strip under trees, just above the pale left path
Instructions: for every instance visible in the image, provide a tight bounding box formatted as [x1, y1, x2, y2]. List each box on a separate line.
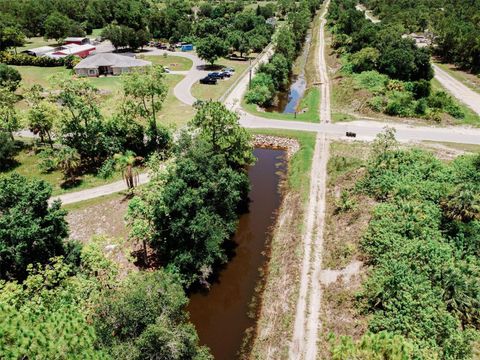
[0, 142, 122, 195]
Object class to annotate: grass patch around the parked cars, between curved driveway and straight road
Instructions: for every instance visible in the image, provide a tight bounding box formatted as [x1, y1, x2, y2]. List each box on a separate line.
[192, 59, 249, 100]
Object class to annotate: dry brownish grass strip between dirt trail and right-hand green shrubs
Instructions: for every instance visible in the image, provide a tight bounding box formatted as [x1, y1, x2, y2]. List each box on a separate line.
[319, 142, 375, 359]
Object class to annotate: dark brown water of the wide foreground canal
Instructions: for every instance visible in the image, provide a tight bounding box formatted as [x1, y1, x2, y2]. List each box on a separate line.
[188, 149, 286, 360]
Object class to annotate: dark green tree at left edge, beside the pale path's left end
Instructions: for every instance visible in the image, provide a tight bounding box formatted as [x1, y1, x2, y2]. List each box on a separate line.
[0, 173, 68, 279]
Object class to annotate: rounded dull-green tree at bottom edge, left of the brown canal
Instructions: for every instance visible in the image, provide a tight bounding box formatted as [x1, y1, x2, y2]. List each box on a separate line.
[94, 270, 211, 360]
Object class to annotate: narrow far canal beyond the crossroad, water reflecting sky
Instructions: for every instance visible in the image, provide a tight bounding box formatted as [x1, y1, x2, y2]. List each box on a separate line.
[265, 33, 311, 114]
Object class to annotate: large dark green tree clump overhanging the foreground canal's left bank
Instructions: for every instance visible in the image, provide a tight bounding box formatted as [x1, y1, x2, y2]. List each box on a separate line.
[128, 102, 253, 287]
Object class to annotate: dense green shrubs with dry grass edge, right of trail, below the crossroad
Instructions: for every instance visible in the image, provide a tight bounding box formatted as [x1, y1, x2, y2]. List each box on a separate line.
[324, 131, 480, 359]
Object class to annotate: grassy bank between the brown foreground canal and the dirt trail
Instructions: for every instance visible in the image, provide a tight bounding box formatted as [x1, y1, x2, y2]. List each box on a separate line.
[249, 129, 315, 359]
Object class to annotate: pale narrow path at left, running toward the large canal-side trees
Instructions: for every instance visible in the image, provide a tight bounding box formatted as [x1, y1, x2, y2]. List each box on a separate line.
[48, 173, 150, 205]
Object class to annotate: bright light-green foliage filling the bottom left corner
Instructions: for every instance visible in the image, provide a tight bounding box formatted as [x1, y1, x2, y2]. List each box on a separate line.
[0, 258, 108, 360]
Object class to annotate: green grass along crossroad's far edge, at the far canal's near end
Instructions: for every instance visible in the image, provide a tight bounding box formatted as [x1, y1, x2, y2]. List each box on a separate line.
[242, 87, 320, 122]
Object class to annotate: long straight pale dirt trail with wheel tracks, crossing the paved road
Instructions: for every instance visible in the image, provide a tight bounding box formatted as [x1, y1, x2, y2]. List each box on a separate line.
[289, 1, 331, 360]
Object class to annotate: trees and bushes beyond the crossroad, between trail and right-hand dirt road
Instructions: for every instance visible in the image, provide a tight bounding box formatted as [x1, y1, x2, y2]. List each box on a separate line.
[329, 0, 480, 125]
